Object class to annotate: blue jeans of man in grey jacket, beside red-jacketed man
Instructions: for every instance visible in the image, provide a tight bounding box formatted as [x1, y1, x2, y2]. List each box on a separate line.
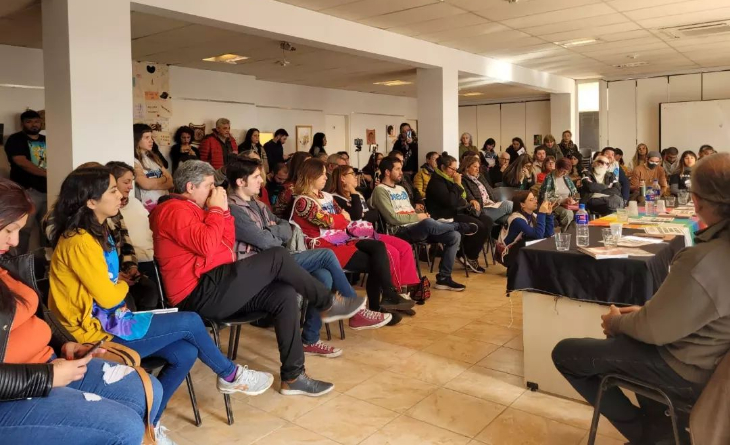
[293, 249, 357, 345]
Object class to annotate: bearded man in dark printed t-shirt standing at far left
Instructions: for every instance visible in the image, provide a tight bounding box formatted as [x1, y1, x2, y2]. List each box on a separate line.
[5, 110, 47, 254]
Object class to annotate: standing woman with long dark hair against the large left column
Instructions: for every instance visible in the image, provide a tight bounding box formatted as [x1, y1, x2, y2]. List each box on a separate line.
[132, 124, 173, 211]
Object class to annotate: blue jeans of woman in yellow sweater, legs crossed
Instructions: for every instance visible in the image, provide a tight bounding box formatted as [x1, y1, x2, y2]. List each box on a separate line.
[114, 312, 236, 423]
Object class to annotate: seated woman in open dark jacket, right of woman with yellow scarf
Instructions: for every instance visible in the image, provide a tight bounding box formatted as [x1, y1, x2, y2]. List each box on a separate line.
[460, 157, 512, 224]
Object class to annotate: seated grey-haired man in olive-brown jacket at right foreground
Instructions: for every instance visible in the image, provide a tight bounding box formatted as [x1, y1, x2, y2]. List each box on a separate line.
[553, 153, 730, 444]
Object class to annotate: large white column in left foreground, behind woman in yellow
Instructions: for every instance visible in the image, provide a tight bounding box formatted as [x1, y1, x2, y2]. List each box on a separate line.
[43, 0, 134, 199]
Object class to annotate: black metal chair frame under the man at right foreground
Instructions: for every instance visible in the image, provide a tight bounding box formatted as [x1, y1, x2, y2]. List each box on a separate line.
[587, 374, 692, 445]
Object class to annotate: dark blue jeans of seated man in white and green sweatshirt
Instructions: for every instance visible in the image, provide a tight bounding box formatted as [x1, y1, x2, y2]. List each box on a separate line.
[395, 218, 461, 280]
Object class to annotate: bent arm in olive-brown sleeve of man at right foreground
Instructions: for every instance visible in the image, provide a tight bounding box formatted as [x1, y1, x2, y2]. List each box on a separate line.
[610, 250, 720, 346]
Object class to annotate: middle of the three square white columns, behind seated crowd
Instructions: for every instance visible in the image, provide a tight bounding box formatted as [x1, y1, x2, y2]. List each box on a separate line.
[417, 68, 459, 165]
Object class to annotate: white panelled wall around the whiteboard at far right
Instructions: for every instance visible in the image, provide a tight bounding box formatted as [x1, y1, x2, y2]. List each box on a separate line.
[601, 71, 730, 158]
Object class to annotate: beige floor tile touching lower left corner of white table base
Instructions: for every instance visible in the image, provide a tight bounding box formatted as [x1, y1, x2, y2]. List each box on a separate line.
[444, 366, 526, 405]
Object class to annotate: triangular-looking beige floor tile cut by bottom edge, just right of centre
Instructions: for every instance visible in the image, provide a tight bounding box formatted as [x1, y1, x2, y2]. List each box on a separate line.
[361, 416, 469, 445]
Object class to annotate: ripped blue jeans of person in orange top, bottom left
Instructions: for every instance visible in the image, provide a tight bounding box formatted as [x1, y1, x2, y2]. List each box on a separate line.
[0, 359, 162, 445]
